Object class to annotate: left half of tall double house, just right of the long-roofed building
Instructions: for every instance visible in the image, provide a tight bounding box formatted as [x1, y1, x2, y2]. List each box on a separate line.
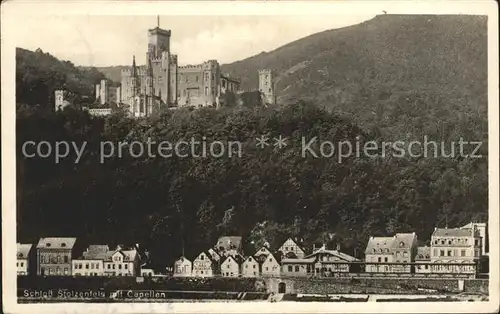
[365, 237, 394, 273]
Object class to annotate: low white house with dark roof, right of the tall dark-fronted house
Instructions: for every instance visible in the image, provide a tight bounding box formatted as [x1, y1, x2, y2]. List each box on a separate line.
[71, 245, 109, 276]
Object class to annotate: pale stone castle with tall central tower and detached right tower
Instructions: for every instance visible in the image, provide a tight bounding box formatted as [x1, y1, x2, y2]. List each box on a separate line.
[90, 17, 275, 117]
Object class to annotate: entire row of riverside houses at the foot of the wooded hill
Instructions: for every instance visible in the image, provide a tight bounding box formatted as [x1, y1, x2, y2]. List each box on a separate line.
[17, 223, 488, 277]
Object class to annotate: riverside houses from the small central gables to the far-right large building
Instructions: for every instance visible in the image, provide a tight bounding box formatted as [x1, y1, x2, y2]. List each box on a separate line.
[174, 222, 487, 277]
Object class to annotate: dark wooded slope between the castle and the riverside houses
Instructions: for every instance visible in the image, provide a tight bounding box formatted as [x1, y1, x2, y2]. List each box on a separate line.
[16, 103, 488, 267]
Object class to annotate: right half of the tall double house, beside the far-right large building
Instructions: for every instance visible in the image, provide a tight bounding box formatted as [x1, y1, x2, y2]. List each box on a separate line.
[390, 232, 417, 273]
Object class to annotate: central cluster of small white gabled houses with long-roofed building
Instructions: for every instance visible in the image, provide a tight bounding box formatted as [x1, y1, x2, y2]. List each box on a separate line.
[174, 237, 359, 277]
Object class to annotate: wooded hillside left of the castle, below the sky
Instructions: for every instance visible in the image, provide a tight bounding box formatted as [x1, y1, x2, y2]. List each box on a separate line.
[16, 48, 104, 109]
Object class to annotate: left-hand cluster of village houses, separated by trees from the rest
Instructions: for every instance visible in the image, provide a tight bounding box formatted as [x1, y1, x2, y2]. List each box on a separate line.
[17, 237, 151, 276]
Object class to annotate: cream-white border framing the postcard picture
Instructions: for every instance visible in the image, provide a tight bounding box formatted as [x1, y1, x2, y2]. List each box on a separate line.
[1, 0, 500, 314]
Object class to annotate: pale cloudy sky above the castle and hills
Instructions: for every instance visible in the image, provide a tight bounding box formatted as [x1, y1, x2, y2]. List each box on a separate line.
[12, 12, 374, 67]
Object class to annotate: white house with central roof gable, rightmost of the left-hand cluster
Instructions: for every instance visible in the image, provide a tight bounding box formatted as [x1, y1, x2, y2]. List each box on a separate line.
[104, 246, 140, 276]
